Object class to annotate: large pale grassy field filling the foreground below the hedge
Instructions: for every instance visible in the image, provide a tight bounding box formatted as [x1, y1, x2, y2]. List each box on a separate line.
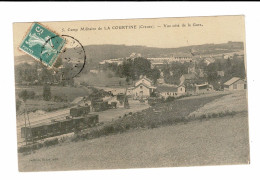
[19, 114, 249, 171]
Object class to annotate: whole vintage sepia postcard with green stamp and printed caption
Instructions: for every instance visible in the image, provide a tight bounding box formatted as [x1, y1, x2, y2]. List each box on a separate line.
[13, 16, 250, 172]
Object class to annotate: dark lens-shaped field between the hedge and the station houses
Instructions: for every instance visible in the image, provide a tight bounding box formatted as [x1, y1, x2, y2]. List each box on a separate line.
[101, 94, 228, 129]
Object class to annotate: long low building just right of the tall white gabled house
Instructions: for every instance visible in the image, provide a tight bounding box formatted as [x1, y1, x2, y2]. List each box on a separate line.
[156, 85, 186, 99]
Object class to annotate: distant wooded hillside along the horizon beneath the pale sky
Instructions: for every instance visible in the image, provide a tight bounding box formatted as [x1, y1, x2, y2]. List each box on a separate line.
[15, 42, 244, 64]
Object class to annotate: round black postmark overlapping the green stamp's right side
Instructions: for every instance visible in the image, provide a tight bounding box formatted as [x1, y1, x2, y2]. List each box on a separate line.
[40, 35, 86, 80]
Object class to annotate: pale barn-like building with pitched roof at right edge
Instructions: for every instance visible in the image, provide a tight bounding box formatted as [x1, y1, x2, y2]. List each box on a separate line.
[224, 77, 246, 91]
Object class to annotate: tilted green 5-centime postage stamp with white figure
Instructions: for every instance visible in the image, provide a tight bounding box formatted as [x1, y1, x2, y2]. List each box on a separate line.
[19, 23, 65, 67]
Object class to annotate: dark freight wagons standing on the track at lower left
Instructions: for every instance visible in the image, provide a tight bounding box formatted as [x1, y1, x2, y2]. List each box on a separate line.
[21, 106, 99, 141]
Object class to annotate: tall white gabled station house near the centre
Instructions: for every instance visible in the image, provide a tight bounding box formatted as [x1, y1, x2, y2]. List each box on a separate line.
[130, 76, 156, 99]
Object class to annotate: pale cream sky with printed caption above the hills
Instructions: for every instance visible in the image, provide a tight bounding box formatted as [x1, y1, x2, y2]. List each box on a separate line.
[13, 16, 245, 56]
